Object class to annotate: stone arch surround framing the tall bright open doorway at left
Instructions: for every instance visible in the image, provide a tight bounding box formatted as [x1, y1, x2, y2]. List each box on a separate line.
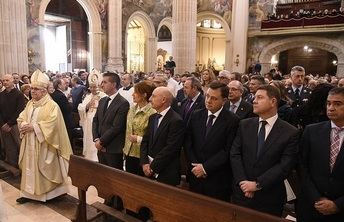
[38, 0, 102, 70]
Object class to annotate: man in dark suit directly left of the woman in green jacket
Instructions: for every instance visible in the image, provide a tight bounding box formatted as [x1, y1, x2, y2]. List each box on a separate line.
[92, 72, 129, 170]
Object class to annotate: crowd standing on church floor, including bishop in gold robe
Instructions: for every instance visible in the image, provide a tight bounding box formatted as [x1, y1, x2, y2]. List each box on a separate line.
[0, 66, 344, 222]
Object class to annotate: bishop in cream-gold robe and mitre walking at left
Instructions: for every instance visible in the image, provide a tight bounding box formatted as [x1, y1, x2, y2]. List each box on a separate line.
[17, 71, 72, 203]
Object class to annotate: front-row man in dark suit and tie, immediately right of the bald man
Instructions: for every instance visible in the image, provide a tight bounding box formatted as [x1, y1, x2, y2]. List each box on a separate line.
[184, 81, 239, 201]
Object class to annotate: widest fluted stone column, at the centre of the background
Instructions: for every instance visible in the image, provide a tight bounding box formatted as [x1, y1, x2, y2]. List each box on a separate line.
[172, 0, 197, 73]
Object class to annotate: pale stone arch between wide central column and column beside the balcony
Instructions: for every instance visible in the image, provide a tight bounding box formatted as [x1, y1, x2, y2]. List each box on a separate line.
[197, 11, 233, 70]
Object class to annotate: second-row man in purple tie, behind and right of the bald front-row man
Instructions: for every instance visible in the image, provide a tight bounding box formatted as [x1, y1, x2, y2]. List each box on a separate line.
[179, 77, 205, 124]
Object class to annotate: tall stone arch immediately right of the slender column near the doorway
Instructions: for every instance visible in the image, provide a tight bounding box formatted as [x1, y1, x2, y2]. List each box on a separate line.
[125, 11, 157, 72]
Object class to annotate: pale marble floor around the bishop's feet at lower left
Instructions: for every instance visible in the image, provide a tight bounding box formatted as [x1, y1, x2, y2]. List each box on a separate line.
[0, 179, 103, 222]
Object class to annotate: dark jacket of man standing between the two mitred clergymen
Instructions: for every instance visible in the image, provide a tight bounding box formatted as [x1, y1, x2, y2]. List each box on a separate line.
[51, 90, 73, 129]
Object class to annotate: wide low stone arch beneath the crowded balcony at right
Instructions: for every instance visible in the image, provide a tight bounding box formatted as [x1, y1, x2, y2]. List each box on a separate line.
[258, 36, 344, 77]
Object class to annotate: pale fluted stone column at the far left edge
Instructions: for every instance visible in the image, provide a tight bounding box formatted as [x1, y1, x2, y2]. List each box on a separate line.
[0, 0, 29, 77]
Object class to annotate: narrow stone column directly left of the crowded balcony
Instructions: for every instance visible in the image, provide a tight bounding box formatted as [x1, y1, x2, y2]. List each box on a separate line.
[230, 0, 249, 73]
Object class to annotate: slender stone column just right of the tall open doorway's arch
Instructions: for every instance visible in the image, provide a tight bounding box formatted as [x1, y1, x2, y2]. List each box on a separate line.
[106, 0, 124, 72]
